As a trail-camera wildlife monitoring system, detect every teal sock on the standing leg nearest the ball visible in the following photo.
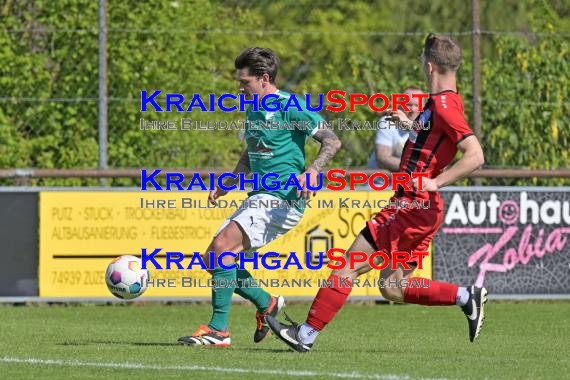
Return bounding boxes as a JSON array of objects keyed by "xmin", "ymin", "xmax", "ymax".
[{"xmin": 208, "ymin": 268, "xmax": 236, "ymax": 331}]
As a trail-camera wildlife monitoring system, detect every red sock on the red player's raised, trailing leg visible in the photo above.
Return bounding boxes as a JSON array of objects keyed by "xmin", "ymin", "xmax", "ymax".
[{"xmin": 404, "ymin": 277, "xmax": 459, "ymax": 306}]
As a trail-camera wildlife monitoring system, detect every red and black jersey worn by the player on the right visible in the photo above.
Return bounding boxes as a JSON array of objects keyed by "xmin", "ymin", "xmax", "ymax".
[{"xmin": 398, "ymin": 90, "xmax": 473, "ymax": 198}]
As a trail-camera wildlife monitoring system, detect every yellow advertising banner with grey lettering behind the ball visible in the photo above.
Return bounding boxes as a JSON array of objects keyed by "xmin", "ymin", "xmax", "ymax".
[{"xmin": 39, "ymin": 191, "xmax": 432, "ymax": 298}]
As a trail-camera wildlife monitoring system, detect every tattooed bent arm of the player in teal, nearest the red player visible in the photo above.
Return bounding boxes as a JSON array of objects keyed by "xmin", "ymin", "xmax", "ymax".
[{"xmin": 297, "ymin": 129, "xmax": 342, "ymax": 199}]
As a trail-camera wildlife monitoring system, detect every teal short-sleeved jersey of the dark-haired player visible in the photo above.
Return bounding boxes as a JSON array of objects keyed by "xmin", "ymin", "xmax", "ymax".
[{"xmin": 245, "ymin": 91, "xmax": 324, "ymax": 212}]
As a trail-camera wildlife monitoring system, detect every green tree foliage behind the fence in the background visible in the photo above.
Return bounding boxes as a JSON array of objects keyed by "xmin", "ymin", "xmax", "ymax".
[{"xmin": 0, "ymin": 0, "xmax": 570, "ymax": 185}]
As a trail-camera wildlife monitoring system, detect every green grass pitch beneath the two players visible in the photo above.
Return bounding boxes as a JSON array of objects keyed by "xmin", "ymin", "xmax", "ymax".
[{"xmin": 0, "ymin": 301, "xmax": 570, "ymax": 380}]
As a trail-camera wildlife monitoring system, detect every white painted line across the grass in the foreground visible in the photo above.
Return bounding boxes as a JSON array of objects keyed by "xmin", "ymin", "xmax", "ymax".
[{"xmin": 0, "ymin": 356, "xmax": 444, "ymax": 380}]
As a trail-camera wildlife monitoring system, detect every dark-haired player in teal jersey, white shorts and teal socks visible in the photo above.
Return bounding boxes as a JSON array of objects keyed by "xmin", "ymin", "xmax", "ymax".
[{"xmin": 178, "ymin": 48, "xmax": 341, "ymax": 347}]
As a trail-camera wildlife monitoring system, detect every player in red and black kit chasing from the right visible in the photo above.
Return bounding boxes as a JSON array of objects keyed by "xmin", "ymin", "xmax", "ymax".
[{"xmin": 267, "ymin": 34, "xmax": 487, "ymax": 352}]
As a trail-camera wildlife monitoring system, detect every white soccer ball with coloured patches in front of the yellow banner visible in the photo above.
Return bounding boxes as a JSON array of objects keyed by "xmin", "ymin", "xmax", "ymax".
[{"xmin": 105, "ymin": 255, "xmax": 150, "ymax": 300}]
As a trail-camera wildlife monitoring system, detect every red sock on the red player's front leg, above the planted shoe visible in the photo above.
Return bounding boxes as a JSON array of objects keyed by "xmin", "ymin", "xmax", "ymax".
[{"xmin": 307, "ymin": 275, "xmax": 352, "ymax": 330}]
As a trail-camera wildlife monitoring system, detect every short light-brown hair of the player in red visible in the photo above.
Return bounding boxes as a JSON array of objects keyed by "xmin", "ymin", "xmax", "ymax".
[{"xmin": 422, "ymin": 33, "xmax": 461, "ymax": 74}]
